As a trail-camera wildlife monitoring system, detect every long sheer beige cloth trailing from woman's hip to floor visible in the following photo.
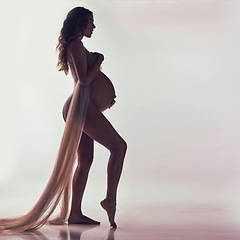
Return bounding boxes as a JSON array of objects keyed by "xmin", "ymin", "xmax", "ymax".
[{"xmin": 0, "ymin": 82, "xmax": 90, "ymax": 234}]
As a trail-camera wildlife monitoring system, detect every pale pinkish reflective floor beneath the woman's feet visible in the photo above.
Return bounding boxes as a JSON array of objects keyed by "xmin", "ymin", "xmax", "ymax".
[{"xmin": 0, "ymin": 204, "xmax": 240, "ymax": 240}]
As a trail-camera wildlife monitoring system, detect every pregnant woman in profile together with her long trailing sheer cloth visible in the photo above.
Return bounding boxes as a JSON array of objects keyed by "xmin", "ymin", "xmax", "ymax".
[{"xmin": 0, "ymin": 7, "xmax": 127, "ymax": 235}]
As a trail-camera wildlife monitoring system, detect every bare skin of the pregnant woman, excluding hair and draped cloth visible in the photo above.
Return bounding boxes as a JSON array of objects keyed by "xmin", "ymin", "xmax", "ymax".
[{"xmin": 63, "ymin": 15, "xmax": 127, "ymax": 228}]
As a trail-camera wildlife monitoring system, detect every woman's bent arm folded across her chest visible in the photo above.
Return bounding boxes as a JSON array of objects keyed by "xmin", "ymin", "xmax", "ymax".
[{"xmin": 68, "ymin": 39, "xmax": 104, "ymax": 86}]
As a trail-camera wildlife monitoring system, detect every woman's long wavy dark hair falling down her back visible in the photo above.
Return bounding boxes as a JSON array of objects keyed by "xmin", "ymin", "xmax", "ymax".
[{"xmin": 56, "ymin": 7, "xmax": 92, "ymax": 75}]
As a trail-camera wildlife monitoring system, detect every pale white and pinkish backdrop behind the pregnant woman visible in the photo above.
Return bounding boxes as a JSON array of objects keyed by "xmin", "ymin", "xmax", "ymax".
[{"xmin": 0, "ymin": 0, "xmax": 240, "ymax": 222}]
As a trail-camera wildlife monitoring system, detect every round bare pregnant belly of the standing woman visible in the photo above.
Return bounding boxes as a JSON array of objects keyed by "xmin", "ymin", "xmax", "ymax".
[{"xmin": 91, "ymin": 71, "xmax": 116, "ymax": 111}]
